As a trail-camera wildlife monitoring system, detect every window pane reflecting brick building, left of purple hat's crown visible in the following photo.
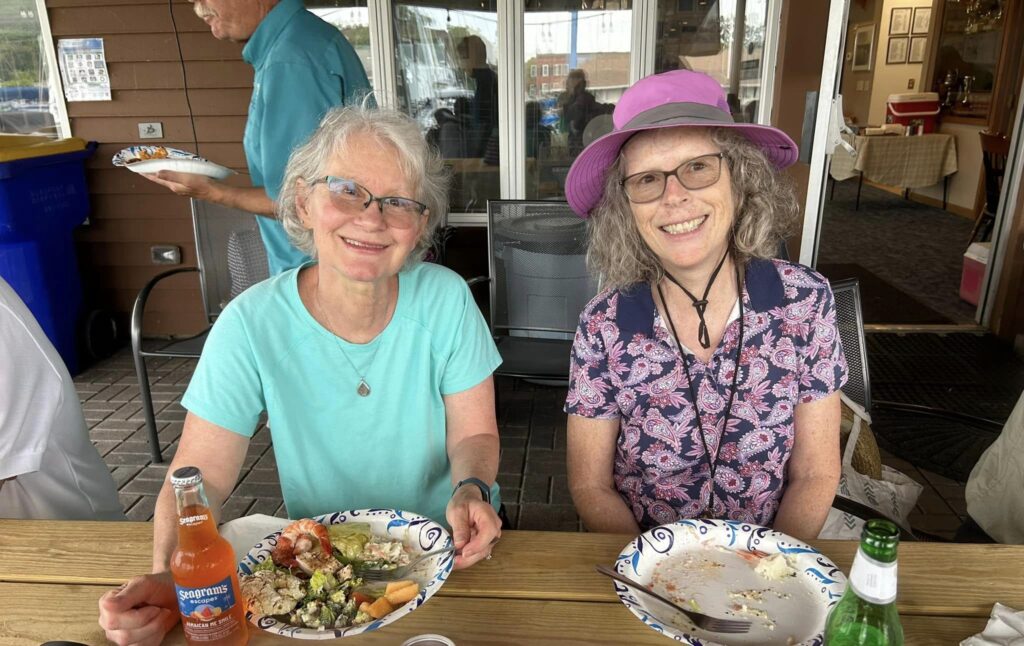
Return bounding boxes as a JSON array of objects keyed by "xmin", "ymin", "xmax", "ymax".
[{"xmin": 523, "ymin": 0, "xmax": 633, "ymax": 200}]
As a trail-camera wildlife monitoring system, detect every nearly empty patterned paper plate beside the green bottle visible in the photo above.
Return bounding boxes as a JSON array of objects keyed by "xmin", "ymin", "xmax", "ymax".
[{"xmin": 613, "ymin": 519, "xmax": 846, "ymax": 646}]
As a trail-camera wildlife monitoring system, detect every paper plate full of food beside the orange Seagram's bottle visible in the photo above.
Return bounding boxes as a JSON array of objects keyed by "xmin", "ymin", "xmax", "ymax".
[{"xmin": 239, "ymin": 509, "xmax": 455, "ymax": 639}]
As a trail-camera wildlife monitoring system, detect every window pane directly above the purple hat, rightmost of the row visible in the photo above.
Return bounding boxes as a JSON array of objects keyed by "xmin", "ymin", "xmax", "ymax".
[{"xmin": 654, "ymin": 0, "xmax": 767, "ymax": 122}]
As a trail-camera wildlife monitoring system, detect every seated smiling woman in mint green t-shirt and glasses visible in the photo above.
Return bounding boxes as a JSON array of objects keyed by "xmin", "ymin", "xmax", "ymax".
[{"xmin": 162, "ymin": 106, "xmax": 501, "ymax": 581}]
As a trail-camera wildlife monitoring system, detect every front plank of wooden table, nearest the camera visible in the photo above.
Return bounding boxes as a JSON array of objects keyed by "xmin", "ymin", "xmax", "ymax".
[{"xmin": 0, "ymin": 584, "xmax": 985, "ymax": 646}]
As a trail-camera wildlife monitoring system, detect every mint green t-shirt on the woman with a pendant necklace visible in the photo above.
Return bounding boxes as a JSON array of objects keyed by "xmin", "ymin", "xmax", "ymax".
[{"xmin": 182, "ymin": 263, "xmax": 501, "ymax": 524}]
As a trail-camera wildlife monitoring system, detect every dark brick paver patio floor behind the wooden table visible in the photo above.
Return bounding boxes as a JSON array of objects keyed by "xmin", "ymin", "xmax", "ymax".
[{"xmin": 75, "ymin": 349, "xmax": 967, "ymax": 537}]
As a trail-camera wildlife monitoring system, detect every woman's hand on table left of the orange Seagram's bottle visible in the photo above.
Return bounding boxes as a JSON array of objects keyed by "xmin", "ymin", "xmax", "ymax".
[{"xmin": 99, "ymin": 572, "xmax": 180, "ymax": 646}]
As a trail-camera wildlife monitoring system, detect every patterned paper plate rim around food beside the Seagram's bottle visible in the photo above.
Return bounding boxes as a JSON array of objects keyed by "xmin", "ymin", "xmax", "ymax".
[{"xmin": 239, "ymin": 509, "xmax": 455, "ymax": 639}]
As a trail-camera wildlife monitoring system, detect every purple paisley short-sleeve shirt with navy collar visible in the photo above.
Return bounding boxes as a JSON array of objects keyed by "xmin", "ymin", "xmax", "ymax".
[{"xmin": 565, "ymin": 260, "xmax": 847, "ymax": 527}]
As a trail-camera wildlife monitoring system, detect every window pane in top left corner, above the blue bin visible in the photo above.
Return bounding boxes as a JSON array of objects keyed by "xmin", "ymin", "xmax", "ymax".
[{"xmin": 0, "ymin": 0, "xmax": 61, "ymax": 137}]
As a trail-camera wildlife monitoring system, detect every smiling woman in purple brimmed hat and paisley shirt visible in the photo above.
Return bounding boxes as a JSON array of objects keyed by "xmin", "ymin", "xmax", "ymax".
[{"xmin": 565, "ymin": 71, "xmax": 847, "ymax": 540}]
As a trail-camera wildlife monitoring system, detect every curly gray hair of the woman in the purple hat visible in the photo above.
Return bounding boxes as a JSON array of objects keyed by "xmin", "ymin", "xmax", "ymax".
[{"xmin": 587, "ymin": 128, "xmax": 800, "ymax": 289}]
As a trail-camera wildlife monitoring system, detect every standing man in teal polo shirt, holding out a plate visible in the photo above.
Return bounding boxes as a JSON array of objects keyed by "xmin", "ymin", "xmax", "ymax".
[{"xmin": 146, "ymin": 0, "xmax": 371, "ymax": 275}]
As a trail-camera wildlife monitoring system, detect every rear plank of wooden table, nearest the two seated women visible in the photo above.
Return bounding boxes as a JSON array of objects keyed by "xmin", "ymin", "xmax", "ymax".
[{"xmin": 0, "ymin": 520, "xmax": 1024, "ymax": 616}]
